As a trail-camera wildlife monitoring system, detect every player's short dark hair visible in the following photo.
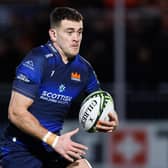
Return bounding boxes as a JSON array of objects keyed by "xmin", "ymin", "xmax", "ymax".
[{"xmin": 50, "ymin": 7, "xmax": 83, "ymax": 28}]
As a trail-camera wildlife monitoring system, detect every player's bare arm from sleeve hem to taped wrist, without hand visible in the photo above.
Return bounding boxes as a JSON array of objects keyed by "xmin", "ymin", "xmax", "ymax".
[{"xmin": 8, "ymin": 91, "xmax": 58, "ymax": 147}]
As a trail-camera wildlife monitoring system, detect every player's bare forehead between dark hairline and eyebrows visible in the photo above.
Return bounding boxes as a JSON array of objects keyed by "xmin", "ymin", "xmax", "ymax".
[{"xmin": 60, "ymin": 19, "xmax": 83, "ymax": 30}]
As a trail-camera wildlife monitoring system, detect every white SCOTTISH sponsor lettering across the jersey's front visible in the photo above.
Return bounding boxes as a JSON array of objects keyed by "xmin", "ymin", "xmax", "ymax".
[{"xmin": 40, "ymin": 90, "xmax": 72, "ymax": 104}]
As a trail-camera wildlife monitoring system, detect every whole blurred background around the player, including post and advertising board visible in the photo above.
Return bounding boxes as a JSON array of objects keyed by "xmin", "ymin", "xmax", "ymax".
[{"xmin": 0, "ymin": 0, "xmax": 168, "ymax": 168}]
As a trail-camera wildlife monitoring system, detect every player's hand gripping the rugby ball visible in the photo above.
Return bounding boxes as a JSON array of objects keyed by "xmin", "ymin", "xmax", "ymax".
[{"xmin": 96, "ymin": 112, "xmax": 119, "ymax": 132}]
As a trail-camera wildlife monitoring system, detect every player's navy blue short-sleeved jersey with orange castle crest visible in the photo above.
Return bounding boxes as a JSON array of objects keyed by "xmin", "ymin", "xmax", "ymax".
[{"xmin": 7, "ymin": 42, "xmax": 99, "ymax": 138}]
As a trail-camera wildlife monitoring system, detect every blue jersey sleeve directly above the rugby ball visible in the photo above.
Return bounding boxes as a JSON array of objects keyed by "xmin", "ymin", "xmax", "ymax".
[{"xmin": 86, "ymin": 65, "xmax": 100, "ymax": 93}]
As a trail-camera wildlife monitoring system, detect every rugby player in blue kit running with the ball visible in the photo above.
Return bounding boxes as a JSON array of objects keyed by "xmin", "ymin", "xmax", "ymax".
[{"xmin": 0, "ymin": 7, "xmax": 118, "ymax": 168}]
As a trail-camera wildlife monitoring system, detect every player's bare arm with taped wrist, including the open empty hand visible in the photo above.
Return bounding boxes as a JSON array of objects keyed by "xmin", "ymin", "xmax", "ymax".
[{"xmin": 8, "ymin": 91, "xmax": 87, "ymax": 161}]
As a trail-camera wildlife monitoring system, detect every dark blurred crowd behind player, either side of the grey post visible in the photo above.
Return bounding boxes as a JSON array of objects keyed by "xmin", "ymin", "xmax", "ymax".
[{"xmin": 0, "ymin": 0, "xmax": 168, "ymax": 88}]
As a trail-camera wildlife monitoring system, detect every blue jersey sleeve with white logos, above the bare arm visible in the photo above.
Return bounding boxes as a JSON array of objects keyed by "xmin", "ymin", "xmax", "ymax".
[{"xmin": 12, "ymin": 52, "xmax": 44, "ymax": 99}]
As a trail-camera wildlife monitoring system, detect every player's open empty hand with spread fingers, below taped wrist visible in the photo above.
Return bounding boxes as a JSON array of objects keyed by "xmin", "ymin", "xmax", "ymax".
[{"xmin": 54, "ymin": 128, "xmax": 88, "ymax": 162}]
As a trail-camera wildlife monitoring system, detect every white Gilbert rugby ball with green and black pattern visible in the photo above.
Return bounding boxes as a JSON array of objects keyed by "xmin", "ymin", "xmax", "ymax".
[{"xmin": 79, "ymin": 90, "xmax": 114, "ymax": 132}]
